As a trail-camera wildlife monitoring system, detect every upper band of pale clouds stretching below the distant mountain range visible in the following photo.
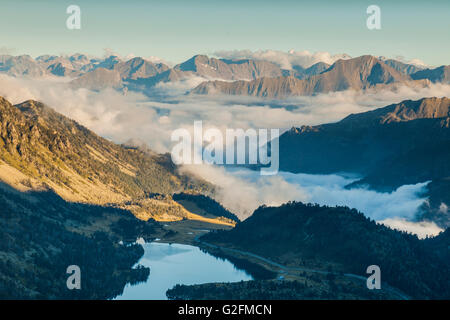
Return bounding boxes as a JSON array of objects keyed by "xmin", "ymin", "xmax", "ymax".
[{"xmin": 0, "ymin": 75, "xmax": 450, "ymax": 152}]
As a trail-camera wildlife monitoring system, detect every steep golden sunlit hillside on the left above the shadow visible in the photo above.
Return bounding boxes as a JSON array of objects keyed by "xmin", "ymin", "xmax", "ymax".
[{"xmin": 0, "ymin": 98, "xmax": 211, "ymax": 219}]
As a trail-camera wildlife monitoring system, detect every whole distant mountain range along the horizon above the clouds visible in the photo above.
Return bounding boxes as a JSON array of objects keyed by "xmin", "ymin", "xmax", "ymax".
[{"xmin": 0, "ymin": 54, "xmax": 450, "ymax": 98}]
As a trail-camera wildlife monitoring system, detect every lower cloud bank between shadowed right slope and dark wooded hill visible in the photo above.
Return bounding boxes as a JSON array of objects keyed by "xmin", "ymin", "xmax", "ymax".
[{"xmin": 184, "ymin": 165, "xmax": 443, "ymax": 238}]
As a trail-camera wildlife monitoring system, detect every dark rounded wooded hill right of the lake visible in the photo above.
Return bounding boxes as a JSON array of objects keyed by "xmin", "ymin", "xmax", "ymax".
[{"xmin": 202, "ymin": 202, "xmax": 450, "ymax": 299}]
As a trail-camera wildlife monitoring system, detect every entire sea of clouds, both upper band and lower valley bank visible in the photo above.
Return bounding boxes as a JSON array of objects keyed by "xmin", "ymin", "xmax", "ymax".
[{"xmin": 0, "ymin": 75, "xmax": 450, "ymax": 236}]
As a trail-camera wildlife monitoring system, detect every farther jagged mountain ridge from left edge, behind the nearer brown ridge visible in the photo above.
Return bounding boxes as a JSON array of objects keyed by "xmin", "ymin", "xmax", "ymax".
[{"xmin": 0, "ymin": 54, "xmax": 329, "ymax": 80}]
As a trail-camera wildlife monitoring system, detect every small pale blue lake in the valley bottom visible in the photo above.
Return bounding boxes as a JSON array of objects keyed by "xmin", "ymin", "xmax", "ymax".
[{"xmin": 116, "ymin": 242, "xmax": 252, "ymax": 300}]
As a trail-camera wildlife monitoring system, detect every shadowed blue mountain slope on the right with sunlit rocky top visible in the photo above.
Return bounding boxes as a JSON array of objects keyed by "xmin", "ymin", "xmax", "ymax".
[{"xmin": 280, "ymin": 97, "xmax": 450, "ymax": 227}]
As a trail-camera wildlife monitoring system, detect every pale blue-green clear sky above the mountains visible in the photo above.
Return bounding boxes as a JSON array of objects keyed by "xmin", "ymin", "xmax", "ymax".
[{"xmin": 0, "ymin": 0, "xmax": 450, "ymax": 65}]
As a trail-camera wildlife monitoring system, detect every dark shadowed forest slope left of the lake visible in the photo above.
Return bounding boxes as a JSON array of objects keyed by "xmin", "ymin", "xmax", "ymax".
[{"xmin": 0, "ymin": 184, "xmax": 160, "ymax": 299}]
